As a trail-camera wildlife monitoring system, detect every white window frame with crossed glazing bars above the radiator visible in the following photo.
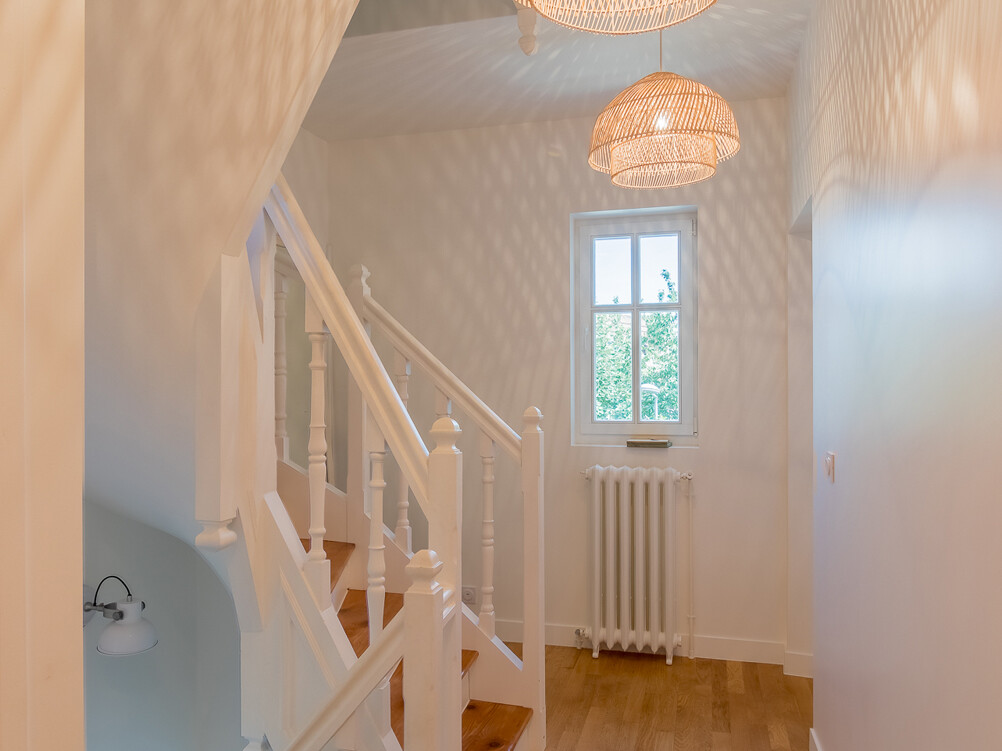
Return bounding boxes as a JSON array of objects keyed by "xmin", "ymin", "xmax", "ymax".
[{"xmin": 570, "ymin": 206, "xmax": 698, "ymax": 446}]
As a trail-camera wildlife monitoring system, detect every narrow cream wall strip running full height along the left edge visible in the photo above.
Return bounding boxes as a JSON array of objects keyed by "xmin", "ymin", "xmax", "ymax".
[{"xmin": 0, "ymin": 0, "xmax": 84, "ymax": 751}]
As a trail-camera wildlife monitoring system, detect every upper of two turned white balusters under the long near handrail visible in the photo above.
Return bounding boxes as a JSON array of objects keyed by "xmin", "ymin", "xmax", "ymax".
[{"xmin": 306, "ymin": 293, "xmax": 331, "ymax": 608}]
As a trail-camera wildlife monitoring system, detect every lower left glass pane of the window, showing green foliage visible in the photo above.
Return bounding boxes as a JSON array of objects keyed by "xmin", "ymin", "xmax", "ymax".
[{"xmin": 594, "ymin": 313, "xmax": 633, "ymax": 423}]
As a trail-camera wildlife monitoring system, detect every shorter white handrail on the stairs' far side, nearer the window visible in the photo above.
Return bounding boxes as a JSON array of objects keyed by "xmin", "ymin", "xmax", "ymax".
[{"xmin": 365, "ymin": 295, "xmax": 522, "ymax": 461}]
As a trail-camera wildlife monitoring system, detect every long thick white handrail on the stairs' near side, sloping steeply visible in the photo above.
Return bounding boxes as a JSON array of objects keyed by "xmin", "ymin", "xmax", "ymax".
[{"xmin": 265, "ymin": 174, "xmax": 430, "ymax": 509}]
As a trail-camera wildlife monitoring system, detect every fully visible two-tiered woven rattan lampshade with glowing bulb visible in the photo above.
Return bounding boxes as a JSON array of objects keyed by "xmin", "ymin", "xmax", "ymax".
[{"xmin": 588, "ymin": 71, "xmax": 740, "ymax": 188}]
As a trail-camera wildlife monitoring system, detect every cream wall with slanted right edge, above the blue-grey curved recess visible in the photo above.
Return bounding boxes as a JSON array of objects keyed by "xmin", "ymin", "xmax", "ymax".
[{"xmin": 86, "ymin": 0, "xmax": 356, "ymax": 541}]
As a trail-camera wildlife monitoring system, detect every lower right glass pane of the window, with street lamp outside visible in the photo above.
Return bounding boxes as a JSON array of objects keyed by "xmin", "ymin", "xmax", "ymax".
[{"xmin": 640, "ymin": 310, "xmax": 678, "ymax": 423}]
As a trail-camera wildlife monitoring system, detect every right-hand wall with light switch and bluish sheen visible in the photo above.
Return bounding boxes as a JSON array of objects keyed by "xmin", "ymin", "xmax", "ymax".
[{"xmin": 792, "ymin": 0, "xmax": 1002, "ymax": 751}]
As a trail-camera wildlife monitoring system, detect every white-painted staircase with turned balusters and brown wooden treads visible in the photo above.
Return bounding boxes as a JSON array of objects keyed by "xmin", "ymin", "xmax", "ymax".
[{"xmin": 196, "ymin": 175, "xmax": 546, "ymax": 751}]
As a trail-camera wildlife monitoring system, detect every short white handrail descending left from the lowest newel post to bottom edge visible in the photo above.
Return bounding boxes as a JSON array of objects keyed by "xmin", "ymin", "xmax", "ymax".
[{"xmin": 287, "ymin": 614, "xmax": 404, "ymax": 751}]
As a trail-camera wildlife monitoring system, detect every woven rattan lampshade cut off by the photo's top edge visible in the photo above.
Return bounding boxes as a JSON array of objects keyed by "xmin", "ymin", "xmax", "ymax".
[{"xmin": 515, "ymin": 0, "xmax": 716, "ymax": 34}]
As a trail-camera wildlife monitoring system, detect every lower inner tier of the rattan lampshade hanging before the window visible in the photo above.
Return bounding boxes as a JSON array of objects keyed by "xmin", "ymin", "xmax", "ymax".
[{"xmin": 609, "ymin": 133, "xmax": 716, "ymax": 188}]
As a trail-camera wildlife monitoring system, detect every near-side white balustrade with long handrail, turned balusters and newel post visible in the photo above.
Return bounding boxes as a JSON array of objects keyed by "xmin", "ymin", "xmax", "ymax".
[{"xmin": 265, "ymin": 176, "xmax": 462, "ymax": 751}]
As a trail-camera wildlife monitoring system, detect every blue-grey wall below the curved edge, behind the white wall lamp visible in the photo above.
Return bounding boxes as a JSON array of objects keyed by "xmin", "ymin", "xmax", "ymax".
[{"xmin": 84, "ymin": 503, "xmax": 244, "ymax": 751}]
